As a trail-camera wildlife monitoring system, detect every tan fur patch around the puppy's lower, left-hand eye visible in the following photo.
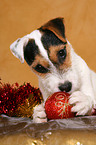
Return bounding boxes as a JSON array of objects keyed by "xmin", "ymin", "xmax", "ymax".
[{"xmin": 30, "ymin": 55, "xmax": 49, "ymax": 77}]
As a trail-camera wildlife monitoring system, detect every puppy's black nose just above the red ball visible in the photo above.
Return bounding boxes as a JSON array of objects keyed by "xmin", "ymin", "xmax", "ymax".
[{"xmin": 58, "ymin": 81, "xmax": 72, "ymax": 92}]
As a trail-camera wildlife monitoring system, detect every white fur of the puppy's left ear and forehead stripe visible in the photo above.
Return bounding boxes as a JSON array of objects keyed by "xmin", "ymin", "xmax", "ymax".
[{"xmin": 10, "ymin": 30, "xmax": 48, "ymax": 63}]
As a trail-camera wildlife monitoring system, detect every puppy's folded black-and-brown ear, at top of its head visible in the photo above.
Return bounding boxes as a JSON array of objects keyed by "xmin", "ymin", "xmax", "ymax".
[{"xmin": 40, "ymin": 18, "xmax": 66, "ymax": 43}]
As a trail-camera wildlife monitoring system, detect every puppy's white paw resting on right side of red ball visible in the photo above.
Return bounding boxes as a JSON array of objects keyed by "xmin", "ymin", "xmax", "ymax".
[{"xmin": 69, "ymin": 91, "xmax": 93, "ymax": 115}]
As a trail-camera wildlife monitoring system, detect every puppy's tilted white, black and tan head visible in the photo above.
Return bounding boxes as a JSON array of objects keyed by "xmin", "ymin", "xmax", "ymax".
[{"xmin": 10, "ymin": 18, "xmax": 80, "ymax": 98}]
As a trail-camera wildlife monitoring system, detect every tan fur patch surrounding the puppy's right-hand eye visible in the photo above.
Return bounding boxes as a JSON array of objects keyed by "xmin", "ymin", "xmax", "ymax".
[{"xmin": 49, "ymin": 44, "xmax": 72, "ymax": 70}]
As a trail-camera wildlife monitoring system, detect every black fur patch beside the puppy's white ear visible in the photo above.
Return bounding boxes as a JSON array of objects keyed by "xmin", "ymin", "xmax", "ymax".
[{"xmin": 24, "ymin": 39, "xmax": 39, "ymax": 65}]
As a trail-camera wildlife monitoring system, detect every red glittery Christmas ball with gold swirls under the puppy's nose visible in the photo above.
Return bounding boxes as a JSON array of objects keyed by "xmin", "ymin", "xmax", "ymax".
[{"xmin": 45, "ymin": 92, "xmax": 75, "ymax": 119}]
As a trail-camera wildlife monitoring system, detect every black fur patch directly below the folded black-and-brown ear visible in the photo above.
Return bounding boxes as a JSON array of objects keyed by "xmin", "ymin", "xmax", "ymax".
[{"xmin": 41, "ymin": 30, "xmax": 65, "ymax": 50}]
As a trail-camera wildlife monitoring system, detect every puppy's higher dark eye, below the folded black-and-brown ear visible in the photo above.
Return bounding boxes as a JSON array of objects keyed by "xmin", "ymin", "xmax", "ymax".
[{"xmin": 57, "ymin": 46, "xmax": 67, "ymax": 63}]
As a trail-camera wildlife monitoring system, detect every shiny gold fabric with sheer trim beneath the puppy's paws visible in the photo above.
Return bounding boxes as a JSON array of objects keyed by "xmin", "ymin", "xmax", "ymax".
[{"xmin": 0, "ymin": 116, "xmax": 96, "ymax": 145}]
